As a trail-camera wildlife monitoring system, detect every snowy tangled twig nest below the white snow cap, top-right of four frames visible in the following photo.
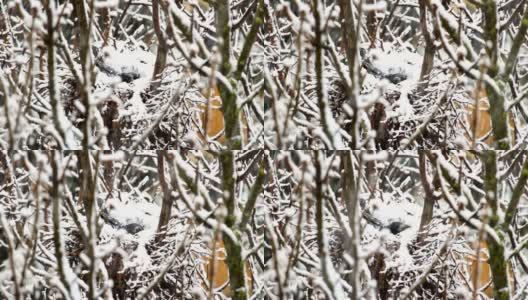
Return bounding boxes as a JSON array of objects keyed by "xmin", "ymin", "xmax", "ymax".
[{"xmin": 363, "ymin": 68, "xmax": 461, "ymax": 150}]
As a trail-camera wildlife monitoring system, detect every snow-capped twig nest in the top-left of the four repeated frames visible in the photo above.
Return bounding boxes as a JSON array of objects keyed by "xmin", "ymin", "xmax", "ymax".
[{"xmin": 36, "ymin": 39, "xmax": 213, "ymax": 149}]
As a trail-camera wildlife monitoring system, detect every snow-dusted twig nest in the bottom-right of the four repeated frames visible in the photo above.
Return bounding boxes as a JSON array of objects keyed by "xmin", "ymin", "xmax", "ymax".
[{"xmin": 369, "ymin": 218, "xmax": 466, "ymax": 299}]
